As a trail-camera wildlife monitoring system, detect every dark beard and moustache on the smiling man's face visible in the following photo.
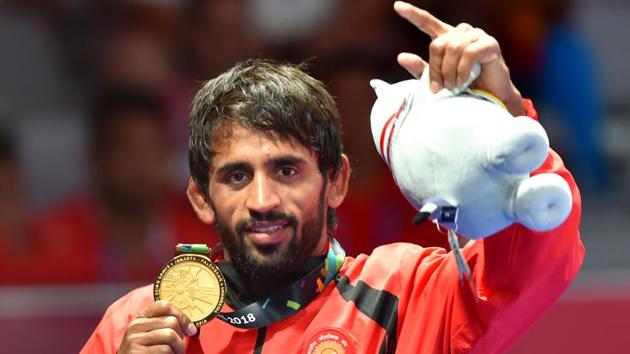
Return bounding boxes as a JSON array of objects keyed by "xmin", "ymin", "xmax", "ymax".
[{"xmin": 210, "ymin": 185, "xmax": 326, "ymax": 279}]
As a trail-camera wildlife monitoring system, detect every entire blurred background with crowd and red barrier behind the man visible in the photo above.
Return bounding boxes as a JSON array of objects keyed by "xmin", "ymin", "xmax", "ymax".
[{"xmin": 0, "ymin": 0, "xmax": 630, "ymax": 354}]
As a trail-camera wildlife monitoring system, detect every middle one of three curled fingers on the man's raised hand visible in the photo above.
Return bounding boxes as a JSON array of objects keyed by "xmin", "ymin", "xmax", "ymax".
[{"xmin": 441, "ymin": 23, "xmax": 473, "ymax": 90}]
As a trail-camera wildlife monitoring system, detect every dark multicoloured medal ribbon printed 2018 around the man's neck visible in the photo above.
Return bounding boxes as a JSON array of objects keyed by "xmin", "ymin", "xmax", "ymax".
[{"xmin": 177, "ymin": 237, "xmax": 346, "ymax": 328}]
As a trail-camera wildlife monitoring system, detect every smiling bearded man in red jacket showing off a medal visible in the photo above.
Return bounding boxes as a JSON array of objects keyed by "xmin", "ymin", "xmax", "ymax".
[{"xmin": 84, "ymin": 2, "xmax": 583, "ymax": 353}]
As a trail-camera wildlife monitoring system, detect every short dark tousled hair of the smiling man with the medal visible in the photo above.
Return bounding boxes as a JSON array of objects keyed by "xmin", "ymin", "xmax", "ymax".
[{"xmin": 188, "ymin": 59, "xmax": 343, "ymax": 229}]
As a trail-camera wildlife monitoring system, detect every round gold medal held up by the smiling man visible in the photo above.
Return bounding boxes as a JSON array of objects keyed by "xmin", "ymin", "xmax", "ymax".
[{"xmin": 153, "ymin": 253, "xmax": 226, "ymax": 327}]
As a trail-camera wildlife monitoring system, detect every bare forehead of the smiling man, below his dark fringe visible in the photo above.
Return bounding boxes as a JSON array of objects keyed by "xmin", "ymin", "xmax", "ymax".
[{"xmin": 211, "ymin": 123, "xmax": 317, "ymax": 170}]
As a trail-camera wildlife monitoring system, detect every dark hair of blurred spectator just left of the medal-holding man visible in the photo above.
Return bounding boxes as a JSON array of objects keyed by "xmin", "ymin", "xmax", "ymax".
[{"xmin": 89, "ymin": 87, "xmax": 168, "ymax": 153}]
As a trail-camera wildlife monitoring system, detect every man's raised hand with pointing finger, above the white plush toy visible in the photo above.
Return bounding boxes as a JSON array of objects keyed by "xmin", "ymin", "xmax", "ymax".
[{"xmin": 394, "ymin": 1, "xmax": 524, "ymax": 116}]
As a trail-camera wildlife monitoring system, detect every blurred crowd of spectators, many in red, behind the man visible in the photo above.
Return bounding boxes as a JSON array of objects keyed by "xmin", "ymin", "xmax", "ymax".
[{"xmin": 0, "ymin": 0, "xmax": 609, "ymax": 284}]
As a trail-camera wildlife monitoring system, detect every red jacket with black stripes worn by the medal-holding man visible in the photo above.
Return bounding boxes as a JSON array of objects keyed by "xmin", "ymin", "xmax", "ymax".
[{"xmin": 82, "ymin": 100, "xmax": 584, "ymax": 354}]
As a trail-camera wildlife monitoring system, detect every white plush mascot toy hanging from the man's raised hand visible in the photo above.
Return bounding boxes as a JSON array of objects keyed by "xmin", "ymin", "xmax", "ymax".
[{"xmin": 370, "ymin": 65, "xmax": 571, "ymax": 245}]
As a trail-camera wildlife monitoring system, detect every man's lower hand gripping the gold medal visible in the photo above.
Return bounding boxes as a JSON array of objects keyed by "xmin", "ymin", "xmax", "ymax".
[{"xmin": 118, "ymin": 301, "xmax": 197, "ymax": 354}]
